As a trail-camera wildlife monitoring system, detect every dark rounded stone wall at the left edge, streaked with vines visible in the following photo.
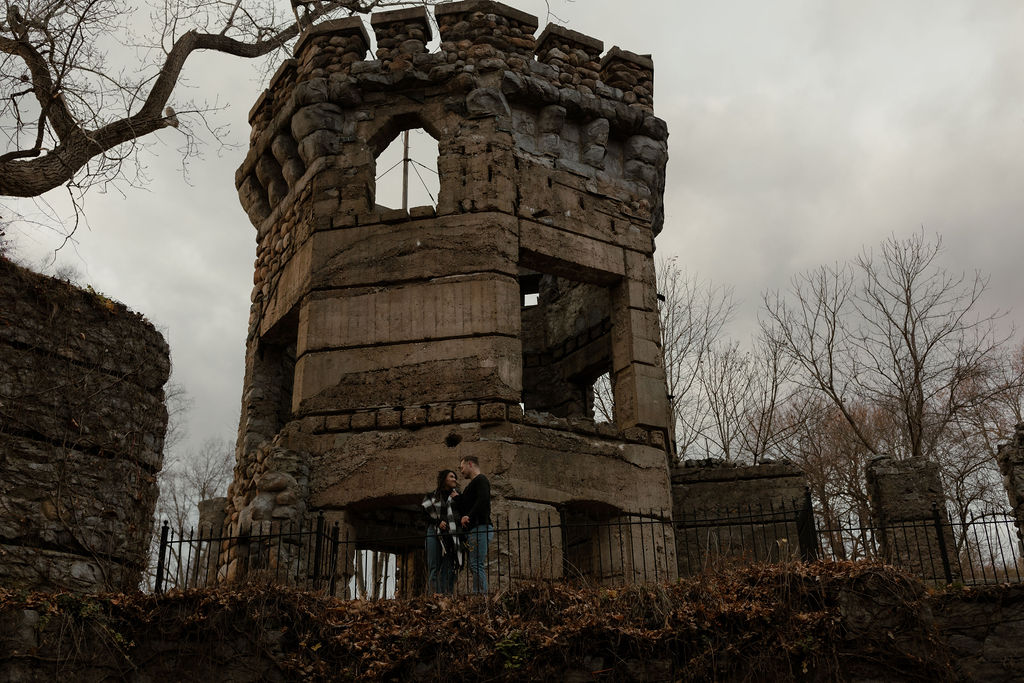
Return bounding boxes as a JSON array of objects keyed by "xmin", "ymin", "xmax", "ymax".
[{"xmin": 0, "ymin": 258, "xmax": 170, "ymax": 591}]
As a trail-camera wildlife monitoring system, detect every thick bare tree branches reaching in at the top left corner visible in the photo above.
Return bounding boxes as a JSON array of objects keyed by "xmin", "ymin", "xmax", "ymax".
[{"xmin": 0, "ymin": 0, "xmax": 437, "ymax": 197}]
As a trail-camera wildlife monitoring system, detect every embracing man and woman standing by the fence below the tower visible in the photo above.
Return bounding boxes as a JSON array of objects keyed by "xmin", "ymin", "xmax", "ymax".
[{"xmin": 423, "ymin": 456, "xmax": 494, "ymax": 593}]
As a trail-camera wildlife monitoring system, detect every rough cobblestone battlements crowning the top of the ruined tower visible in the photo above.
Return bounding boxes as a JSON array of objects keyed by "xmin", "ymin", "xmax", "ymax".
[{"xmin": 236, "ymin": 0, "xmax": 668, "ymax": 323}]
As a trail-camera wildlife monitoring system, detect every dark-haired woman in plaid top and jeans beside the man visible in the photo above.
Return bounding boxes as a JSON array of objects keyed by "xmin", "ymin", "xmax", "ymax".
[{"xmin": 423, "ymin": 470, "xmax": 462, "ymax": 593}]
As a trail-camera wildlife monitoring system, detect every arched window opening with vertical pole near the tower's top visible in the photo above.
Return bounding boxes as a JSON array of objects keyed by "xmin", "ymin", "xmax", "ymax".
[{"xmin": 376, "ymin": 128, "xmax": 440, "ymax": 210}]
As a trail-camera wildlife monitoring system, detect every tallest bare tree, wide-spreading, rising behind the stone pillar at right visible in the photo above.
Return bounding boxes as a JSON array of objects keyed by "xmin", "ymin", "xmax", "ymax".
[{"xmin": 764, "ymin": 233, "xmax": 1020, "ymax": 459}]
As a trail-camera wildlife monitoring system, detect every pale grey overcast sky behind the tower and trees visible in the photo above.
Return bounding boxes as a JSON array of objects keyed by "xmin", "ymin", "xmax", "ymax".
[{"xmin": 11, "ymin": 0, "xmax": 1024, "ymax": 458}]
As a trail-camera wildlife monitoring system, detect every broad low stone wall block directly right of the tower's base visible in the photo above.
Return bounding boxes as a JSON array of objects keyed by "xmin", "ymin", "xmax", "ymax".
[{"xmin": 672, "ymin": 460, "xmax": 807, "ymax": 575}]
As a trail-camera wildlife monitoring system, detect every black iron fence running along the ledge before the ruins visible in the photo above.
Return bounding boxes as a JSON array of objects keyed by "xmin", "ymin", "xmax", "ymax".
[{"xmin": 155, "ymin": 496, "xmax": 1024, "ymax": 598}]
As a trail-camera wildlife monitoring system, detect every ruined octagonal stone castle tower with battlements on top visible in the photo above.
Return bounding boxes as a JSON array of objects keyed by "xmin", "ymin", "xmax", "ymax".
[{"xmin": 222, "ymin": 0, "xmax": 675, "ymax": 589}]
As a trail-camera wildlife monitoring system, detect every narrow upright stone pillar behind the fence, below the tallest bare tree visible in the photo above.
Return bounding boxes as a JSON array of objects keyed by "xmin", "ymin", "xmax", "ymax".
[{"xmin": 866, "ymin": 456, "xmax": 959, "ymax": 583}]
